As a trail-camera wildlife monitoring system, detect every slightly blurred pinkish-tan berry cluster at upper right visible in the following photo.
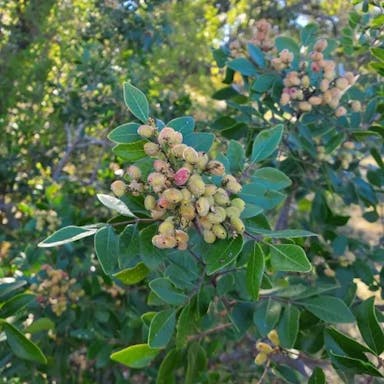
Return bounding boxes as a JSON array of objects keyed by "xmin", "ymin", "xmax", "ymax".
[{"xmin": 271, "ymin": 39, "xmax": 361, "ymax": 117}]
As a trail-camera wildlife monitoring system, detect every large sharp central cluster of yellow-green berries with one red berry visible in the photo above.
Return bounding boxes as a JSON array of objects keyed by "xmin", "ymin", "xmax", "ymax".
[{"xmin": 111, "ymin": 125, "xmax": 245, "ymax": 250}]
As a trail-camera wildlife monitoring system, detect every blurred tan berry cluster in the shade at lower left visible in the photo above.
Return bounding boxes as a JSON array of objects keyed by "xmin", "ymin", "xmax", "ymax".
[{"xmin": 31, "ymin": 265, "xmax": 84, "ymax": 316}]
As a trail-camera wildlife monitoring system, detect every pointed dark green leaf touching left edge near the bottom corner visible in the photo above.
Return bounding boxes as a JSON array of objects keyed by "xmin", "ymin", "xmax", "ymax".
[{"xmin": 0, "ymin": 320, "xmax": 47, "ymax": 364}]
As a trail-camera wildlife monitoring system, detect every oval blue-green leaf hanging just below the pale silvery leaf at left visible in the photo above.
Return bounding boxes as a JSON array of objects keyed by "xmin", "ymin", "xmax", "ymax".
[{"xmin": 94, "ymin": 226, "xmax": 119, "ymax": 275}]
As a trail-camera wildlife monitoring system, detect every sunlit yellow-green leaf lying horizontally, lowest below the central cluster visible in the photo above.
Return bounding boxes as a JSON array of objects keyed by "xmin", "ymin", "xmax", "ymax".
[{"xmin": 111, "ymin": 344, "xmax": 160, "ymax": 368}]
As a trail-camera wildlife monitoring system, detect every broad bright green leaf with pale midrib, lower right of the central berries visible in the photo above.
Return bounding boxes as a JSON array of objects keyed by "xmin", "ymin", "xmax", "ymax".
[{"xmin": 269, "ymin": 244, "xmax": 312, "ymax": 272}]
